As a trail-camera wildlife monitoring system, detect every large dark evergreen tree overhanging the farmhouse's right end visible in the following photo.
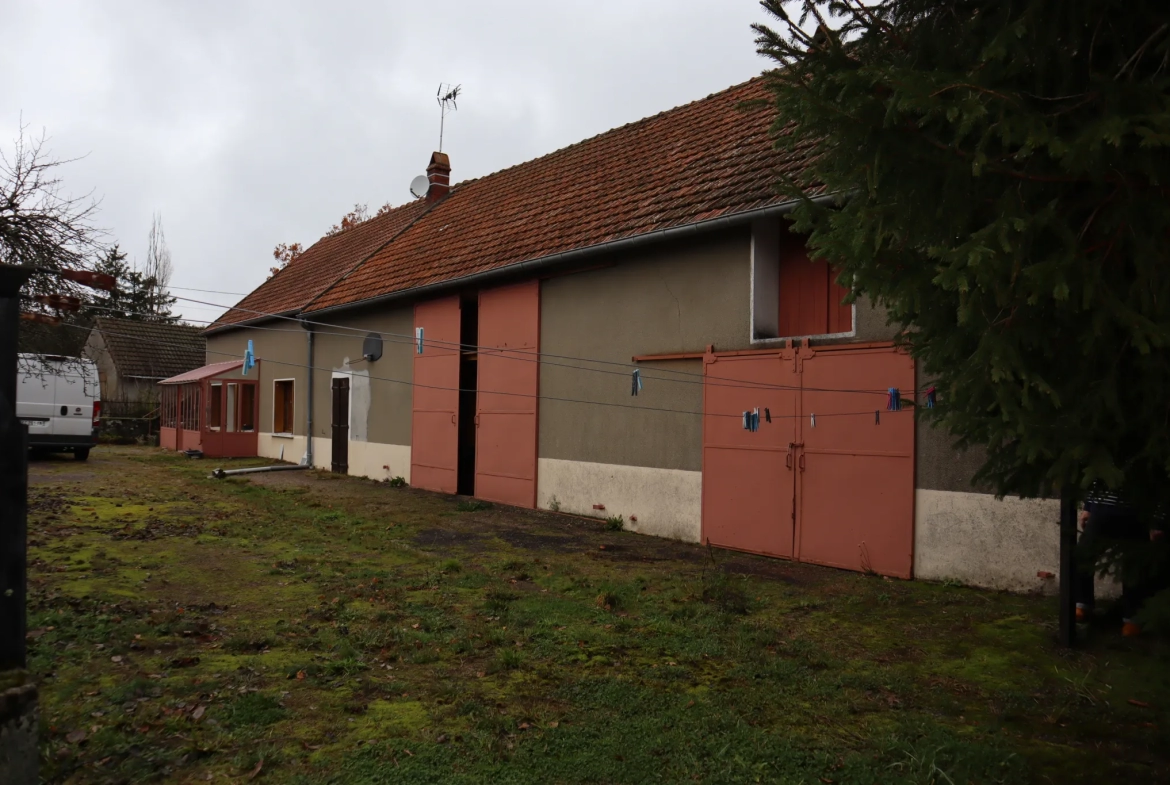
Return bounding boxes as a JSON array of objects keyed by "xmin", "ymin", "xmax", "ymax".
[{"xmin": 755, "ymin": 0, "xmax": 1170, "ymax": 511}]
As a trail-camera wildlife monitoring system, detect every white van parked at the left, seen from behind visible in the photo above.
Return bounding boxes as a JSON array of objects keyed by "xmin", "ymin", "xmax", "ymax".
[{"xmin": 16, "ymin": 354, "xmax": 102, "ymax": 461}]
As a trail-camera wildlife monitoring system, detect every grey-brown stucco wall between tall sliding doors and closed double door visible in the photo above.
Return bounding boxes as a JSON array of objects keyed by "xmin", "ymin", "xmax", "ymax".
[{"xmin": 538, "ymin": 227, "xmax": 751, "ymax": 470}]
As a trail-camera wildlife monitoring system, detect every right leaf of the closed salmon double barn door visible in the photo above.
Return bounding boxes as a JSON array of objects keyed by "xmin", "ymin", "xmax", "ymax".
[{"xmin": 796, "ymin": 346, "xmax": 914, "ymax": 578}]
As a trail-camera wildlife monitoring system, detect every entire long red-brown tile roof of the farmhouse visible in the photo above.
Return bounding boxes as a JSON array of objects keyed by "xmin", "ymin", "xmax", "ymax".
[{"xmin": 209, "ymin": 77, "xmax": 810, "ymax": 330}]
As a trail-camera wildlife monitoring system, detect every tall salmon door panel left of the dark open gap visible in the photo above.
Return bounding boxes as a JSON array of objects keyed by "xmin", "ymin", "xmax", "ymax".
[{"xmin": 411, "ymin": 297, "xmax": 460, "ymax": 494}]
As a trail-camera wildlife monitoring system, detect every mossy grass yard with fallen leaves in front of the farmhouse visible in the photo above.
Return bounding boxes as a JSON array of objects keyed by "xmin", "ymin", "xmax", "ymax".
[{"xmin": 29, "ymin": 447, "xmax": 1170, "ymax": 785}]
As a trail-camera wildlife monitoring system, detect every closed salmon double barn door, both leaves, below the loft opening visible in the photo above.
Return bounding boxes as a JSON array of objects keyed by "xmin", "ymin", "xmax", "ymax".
[{"xmin": 702, "ymin": 345, "xmax": 914, "ymax": 578}]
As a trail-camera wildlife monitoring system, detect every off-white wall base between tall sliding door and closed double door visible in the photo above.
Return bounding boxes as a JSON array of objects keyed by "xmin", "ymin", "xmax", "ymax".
[{"xmin": 536, "ymin": 457, "xmax": 703, "ymax": 543}]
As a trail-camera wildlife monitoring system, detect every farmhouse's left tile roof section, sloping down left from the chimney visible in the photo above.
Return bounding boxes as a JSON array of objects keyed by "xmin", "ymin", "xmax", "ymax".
[{"xmin": 207, "ymin": 200, "xmax": 427, "ymax": 330}]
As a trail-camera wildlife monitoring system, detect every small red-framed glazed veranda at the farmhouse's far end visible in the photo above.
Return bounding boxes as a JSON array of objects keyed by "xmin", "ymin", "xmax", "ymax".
[{"xmin": 159, "ymin": 360, "xmax": 260, "ymax": 457}]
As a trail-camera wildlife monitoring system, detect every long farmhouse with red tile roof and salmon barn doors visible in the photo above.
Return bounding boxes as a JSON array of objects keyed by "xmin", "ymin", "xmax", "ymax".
[{"xmin": 196, "ymin": 80, "xmax": 1058, "ymax": 590}]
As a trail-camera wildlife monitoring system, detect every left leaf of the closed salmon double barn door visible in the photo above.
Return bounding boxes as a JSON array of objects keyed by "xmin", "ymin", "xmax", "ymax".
[{"xmin": 702, "ymin": 349, "xmax": 799, "ymax": 557}]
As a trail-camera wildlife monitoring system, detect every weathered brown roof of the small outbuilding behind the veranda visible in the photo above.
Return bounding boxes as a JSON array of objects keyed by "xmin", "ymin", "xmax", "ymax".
[{"xmin": 94, "ymin": 317, "xmax": 207, "ymax": 379}]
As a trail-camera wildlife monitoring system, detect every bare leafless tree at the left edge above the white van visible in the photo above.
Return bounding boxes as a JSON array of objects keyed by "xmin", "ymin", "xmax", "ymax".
[{"xmin": 0, "ymin": 123, "xmax": 103, "ymax": 354}]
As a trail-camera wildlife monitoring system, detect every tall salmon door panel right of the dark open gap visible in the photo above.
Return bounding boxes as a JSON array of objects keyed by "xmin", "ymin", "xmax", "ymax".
[{"xmin": 475, "ymin": 281, "xmax": 541, "ymax": 508}]
